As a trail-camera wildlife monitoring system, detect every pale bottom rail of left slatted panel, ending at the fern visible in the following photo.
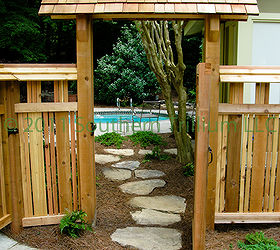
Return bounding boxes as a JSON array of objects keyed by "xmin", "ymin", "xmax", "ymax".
[{"xmin": 22, "ymin": 214, "xmax": 65, "ymax": 227}]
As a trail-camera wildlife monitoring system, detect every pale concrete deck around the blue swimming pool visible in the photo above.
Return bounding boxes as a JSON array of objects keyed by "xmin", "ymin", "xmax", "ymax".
[{"xmin": 94, "ymin": 108, "xmax": 171, "ymax": 135}]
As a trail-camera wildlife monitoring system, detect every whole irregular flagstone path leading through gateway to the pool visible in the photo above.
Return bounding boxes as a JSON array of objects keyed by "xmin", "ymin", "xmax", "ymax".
[{"xmin": 98, "ymin": 148, "xmax": 186, "ymax": 250}]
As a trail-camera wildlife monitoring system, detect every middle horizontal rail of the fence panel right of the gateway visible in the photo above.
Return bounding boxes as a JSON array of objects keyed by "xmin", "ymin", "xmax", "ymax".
[{"xmin": 218, "ymin": 103, "xmax": 280, "ymax": 115}]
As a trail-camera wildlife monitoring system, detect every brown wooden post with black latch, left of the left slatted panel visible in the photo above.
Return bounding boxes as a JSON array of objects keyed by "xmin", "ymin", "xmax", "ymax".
[{"xmin": 5, "ymin": 82, "xmax": 23, "ymax": 233}]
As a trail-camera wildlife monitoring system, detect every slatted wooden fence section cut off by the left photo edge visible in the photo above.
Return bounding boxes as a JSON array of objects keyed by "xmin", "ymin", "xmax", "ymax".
[{"xmin": 0, "ymin": 105, "xmax": 12, "ymax": 229}]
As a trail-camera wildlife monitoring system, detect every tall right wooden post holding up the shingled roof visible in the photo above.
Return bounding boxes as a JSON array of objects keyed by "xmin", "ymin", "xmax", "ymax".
[{"xmin": 205, "ymin": 15, "xmax": 220, "ymax": 229}]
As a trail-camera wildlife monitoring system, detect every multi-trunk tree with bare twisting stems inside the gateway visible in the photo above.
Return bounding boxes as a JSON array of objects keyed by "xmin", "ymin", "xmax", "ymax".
[{"xmin": 136, "ymin": 21, "xmax": 193, "ymax": 164}]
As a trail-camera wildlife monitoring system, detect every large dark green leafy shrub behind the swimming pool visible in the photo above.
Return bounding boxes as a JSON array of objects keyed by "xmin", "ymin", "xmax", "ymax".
[{"xmin": 94, "ymin": 25, "xmax": 159, "ymax": 104}]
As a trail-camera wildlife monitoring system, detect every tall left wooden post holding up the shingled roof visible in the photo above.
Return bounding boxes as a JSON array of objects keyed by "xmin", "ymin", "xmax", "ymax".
[{"xmin": 76, "ymin": 15, "xmax": 96, "ymax": 222}]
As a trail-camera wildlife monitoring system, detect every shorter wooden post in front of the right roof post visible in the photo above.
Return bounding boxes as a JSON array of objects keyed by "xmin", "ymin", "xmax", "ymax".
[{"xmin": 192, "ymin": 63, "xmax": 211, "ymax": 250}]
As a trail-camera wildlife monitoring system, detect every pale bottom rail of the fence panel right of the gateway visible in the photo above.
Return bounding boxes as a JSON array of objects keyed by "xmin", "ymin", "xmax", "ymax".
[{"xmin": 215, "ymin": 213, "xmax": 280, "ymax": 224}]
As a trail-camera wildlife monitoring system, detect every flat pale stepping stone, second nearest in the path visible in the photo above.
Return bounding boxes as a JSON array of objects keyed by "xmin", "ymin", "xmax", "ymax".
[{"xmin": 130, "ymin": 209, "xmax": 181, "ymax": 226}]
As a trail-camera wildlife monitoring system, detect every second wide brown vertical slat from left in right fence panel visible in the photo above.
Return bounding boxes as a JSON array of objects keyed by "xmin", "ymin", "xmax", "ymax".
[{"xmin": 250, "ymin": 83, "xmax": 267, "ymax": 212}]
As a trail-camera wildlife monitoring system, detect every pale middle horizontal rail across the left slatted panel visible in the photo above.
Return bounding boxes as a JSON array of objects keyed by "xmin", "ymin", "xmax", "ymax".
[{"xmin": 15, "ymin": 102, "xmax": 78, "ymax": 113}]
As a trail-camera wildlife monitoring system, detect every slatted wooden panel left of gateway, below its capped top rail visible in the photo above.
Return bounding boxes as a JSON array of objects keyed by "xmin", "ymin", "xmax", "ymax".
[{"xmin": 15, "ymin": 81, "xmax": 79, "ymax": 226}]
